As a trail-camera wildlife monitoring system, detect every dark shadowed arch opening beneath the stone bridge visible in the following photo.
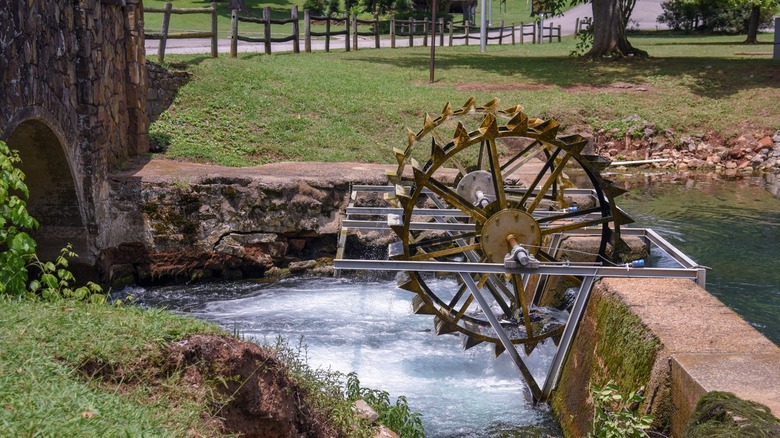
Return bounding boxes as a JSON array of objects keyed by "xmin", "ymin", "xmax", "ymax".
[{"xmin": 5, "ymin": 111, "xmax": 94, "ymax": 264}]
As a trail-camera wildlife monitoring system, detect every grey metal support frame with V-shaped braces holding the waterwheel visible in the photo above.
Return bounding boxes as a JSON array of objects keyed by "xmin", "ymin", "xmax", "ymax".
[{"xmin": 333, "ymin": 185, "xmax": 706, "ymax": 402}]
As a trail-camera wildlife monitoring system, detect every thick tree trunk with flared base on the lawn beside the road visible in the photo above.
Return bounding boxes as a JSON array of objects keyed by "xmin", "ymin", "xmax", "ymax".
[{"xmin": 585, "ymin": 0, "xmax": 647, "ymax": 59}]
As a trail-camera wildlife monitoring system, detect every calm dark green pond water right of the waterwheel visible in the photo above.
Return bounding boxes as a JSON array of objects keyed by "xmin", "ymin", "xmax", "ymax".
[{"xmin": 608, "ymin": 174, "xmax": 780, "ymax": 344}]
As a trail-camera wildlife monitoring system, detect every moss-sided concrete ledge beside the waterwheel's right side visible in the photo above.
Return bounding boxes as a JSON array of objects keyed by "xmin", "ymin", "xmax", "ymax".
[{"xmin": 553, "ymin": 278, "xmax": 780, "ymax": 436}]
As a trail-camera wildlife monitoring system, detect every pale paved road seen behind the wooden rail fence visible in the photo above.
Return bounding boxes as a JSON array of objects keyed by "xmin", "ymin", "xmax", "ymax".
[{"xmin": 146, "ymin": 0, "xmax": 665, "ymax": 56}]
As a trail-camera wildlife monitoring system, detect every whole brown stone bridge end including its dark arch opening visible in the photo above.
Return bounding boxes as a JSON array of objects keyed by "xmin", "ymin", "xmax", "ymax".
[{"xmin": 0, "ymin": 0, "xmax": 149, "ymax": 264}]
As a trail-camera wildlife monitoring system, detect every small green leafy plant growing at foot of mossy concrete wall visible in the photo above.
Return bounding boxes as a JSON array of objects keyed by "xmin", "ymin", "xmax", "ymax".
[{"xmin": 588, "ymin": 380, "xmax": 654, "ymax": 438}]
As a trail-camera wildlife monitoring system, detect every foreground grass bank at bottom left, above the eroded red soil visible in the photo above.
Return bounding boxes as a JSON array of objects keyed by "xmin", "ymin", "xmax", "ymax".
[{"xmin": 0, "ymin": 298, "xmax": 222, "ymax": 436}]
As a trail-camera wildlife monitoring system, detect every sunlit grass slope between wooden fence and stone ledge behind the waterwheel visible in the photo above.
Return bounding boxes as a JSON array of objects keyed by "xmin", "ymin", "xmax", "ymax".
[{"xmin": 150, "ymin": 34, "xmax": 780, "ymax": 166}]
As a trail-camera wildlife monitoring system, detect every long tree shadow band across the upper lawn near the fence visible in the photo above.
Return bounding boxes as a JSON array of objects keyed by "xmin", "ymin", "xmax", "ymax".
[{"xmin": 340, "ymin": 53, "xmax": 780, "ymax": 98}]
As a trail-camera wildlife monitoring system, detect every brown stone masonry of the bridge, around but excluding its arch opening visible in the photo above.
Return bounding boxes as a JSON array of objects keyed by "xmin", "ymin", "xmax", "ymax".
[{"xmin": 0, "ymin": 0, "xmax": 149, "ymax": 258}]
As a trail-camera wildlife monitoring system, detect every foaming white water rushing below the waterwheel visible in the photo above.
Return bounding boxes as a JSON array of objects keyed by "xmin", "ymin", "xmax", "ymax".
[{"xmin": 127, "ymin": 278, "xmax": 560, "ymax": 437}]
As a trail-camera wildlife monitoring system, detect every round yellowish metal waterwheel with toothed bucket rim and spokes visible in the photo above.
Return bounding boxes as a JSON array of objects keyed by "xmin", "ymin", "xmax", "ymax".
[{"xmin": 386, "ymin": 98, "xmax": 631, "ymax": 398}]
